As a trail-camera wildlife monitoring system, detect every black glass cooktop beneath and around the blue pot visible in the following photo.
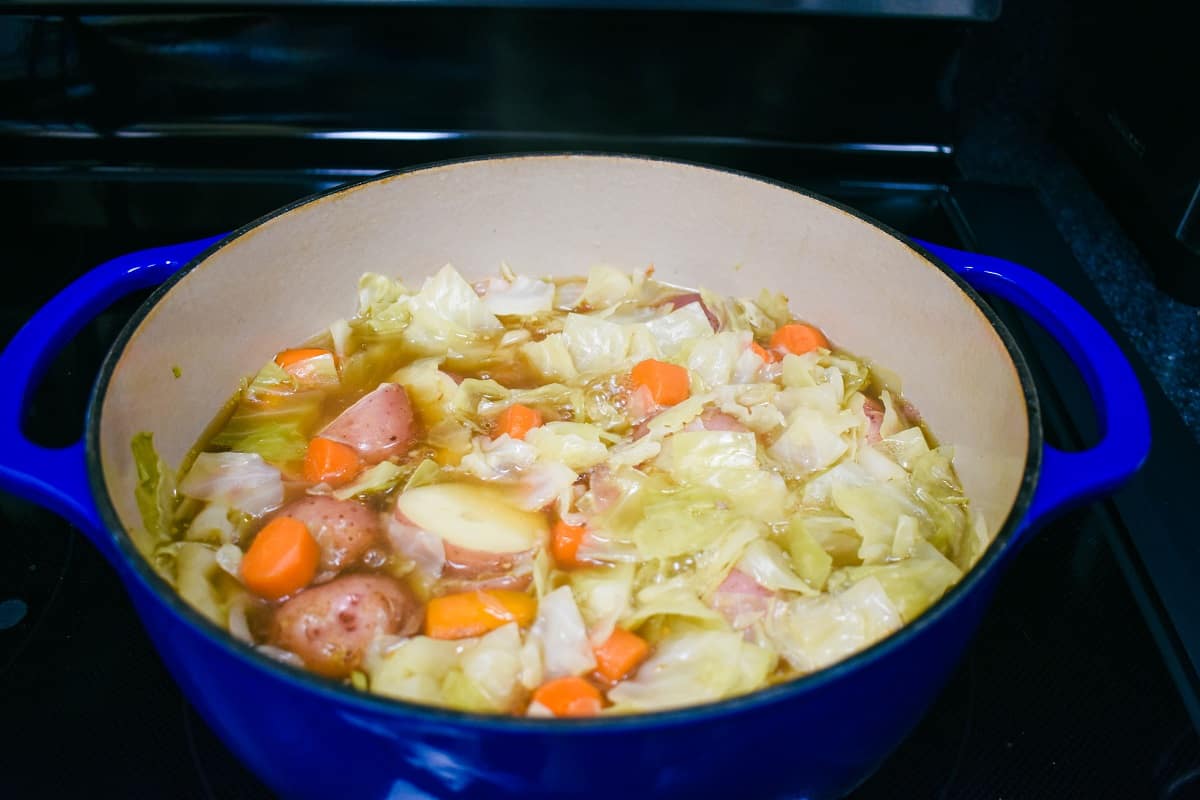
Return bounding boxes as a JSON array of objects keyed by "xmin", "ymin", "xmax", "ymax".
[{"xmin": 0, "ymin": 149, "xmax": 1200, "ymax": 800}]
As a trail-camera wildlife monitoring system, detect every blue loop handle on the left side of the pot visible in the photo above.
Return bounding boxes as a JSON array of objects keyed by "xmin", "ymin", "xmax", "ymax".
[{"xmin": 0, "ymin": 236, "xmax": 221, "ymax": 558}]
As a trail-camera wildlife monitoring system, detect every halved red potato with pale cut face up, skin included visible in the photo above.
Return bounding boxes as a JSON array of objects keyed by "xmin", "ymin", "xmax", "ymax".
[{"xmin": 396, "ymin": 483, "xmax": 550, "ymax": 579}]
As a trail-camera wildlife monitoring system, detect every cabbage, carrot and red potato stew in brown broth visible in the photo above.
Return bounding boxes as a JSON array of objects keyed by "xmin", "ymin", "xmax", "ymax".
[{"xmin": 132, "ymin": 265, "xmax": 989, "ymax": 717}]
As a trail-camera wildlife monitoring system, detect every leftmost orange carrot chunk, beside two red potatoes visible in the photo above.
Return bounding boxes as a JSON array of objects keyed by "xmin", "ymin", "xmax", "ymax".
[{"xmin": 241, "ymin": 517, "xmax": 320, "ymax": 600}]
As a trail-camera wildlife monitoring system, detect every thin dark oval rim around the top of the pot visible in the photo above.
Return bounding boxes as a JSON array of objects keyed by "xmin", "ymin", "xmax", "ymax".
[{"xmin": 84, "ymin": 151, "xmax": 1043, "ymax": 735}]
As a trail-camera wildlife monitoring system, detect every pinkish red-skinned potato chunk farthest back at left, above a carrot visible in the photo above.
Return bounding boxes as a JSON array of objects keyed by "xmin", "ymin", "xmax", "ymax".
[{"xmin": 319, "ymin": 384, "xmax": 416, "ymax": 465}]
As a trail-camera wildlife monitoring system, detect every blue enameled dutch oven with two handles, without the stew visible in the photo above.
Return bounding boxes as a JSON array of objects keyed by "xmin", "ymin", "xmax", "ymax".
[{"xmin": 0, "ymin": 155, "xmax": 1150, "ymax": 800}]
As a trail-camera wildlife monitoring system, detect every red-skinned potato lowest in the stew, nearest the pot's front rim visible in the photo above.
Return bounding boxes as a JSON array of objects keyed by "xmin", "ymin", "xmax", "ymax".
[{"xmin": 270, "ymin": 575, "xmax": 422, "ymax": 678}]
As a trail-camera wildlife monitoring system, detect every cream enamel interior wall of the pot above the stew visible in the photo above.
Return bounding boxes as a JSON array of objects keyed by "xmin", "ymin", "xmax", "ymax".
[{"xmin": 100, "ymin": 156, "xmax": 1028, "ymax": 546}]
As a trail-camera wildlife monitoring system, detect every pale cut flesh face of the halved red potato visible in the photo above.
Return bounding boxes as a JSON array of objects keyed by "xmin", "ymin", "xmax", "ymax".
[{"xmin": 396, "ymin": 483, "xmax": 548, "ymax": 553}]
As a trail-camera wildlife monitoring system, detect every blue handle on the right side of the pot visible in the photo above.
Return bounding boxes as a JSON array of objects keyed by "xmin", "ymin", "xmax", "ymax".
[{"xmin": 917, "ymin": 241, "xmax": 1150, "ymax": 530}]
